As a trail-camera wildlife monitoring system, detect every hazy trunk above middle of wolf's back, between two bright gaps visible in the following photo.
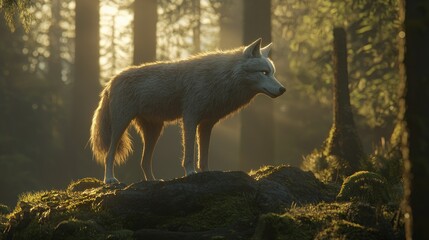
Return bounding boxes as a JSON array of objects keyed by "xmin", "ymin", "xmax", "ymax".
[{"xmin": 133, "ymin": 0, "xmax": 158, "ymax": 65}]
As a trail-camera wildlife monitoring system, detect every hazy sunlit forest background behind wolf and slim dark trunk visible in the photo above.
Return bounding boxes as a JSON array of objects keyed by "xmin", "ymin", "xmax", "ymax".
[{"xmin": 0, "ymin": 0, "xmax": 399, "ymax": 205}]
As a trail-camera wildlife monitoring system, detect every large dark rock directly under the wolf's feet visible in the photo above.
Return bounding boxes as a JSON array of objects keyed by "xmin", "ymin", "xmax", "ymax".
[{"xmin": 99, "ymin": 171, "xmax": 257, "ymax": 231}]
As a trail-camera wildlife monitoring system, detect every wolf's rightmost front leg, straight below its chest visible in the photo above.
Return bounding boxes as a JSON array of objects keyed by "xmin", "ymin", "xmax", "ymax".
[{"xmin": 198, "ymin": 122, "xmax": 214, "ymax": 172}]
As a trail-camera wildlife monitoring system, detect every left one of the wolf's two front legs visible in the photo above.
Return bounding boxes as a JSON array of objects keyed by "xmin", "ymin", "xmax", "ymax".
[{"xmin": 182, "ymin": 119, "xmax": 197, "ymax": 176}]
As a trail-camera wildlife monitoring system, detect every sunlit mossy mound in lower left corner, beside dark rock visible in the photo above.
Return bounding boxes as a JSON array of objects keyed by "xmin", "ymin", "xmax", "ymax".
[{"xmin": 5, "ymin": 179, "xmax": 122, "ymax": 239}]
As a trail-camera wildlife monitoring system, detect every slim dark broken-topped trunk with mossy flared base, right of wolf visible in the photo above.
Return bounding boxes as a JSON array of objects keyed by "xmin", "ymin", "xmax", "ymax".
[{"xmin": 324, "ymin": 28, "xmax": 364, "ymax": 177}]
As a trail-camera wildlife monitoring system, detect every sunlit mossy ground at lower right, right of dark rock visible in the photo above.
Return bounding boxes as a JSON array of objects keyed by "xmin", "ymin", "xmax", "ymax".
[{"xmin": 253, "ymin": 202, "xmax": 403, "ymax": 240}]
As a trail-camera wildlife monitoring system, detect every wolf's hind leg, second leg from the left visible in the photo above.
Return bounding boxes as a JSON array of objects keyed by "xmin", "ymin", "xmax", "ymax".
[{"xmin": 135, "ymin": 117, "xmax": 164, "ymax": 180}]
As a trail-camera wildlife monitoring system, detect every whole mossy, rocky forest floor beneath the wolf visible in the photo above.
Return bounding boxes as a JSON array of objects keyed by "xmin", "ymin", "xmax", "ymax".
[{"xmin": 0, "ymin": 166, "xmax": 404, "ymax": 240}]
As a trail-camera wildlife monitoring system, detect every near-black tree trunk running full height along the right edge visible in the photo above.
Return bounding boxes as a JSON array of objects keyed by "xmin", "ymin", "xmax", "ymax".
[{"xmin": 399, "ymin": 0, "xmax": 429, "ymax": 240}]
